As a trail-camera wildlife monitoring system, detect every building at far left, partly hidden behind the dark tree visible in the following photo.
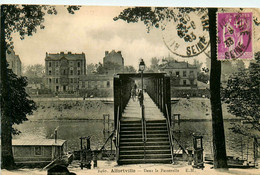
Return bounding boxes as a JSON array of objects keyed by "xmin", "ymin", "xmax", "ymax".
[{"xmin": 6, "ymin": 49, "xmax": 22, "ymax": 76}]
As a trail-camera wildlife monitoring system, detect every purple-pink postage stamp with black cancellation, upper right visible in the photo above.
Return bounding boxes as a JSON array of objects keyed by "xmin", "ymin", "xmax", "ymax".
[{"xmin": 217, "ymin": 12, "xmax": 253, "ymax": 60}]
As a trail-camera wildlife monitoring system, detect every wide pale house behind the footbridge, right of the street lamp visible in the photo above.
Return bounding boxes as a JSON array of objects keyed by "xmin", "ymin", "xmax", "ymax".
[{"xmin": 161, "ymin": 61, "xmax": 197, "ymax": 89}]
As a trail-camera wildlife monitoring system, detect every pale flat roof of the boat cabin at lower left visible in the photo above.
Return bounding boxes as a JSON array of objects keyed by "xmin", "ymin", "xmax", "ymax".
[{"xmin": 12, "ymin": 139, "xmax": 66, "ymax": 146}]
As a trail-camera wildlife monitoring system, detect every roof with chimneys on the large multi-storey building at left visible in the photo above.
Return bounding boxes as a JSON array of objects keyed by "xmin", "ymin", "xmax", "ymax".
[{"xmin": 45, "ymin": 52, "xmax": 85, "ymax": 61}]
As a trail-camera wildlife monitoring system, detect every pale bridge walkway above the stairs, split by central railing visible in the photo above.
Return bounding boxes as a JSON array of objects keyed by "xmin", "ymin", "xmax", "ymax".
[{"xmin": 122, "ymin": 92, "xmax": 165, "ymax": 120}]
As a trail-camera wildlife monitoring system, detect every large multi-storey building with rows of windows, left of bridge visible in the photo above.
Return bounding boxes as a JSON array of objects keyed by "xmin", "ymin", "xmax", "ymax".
[{"xmin": 45, "ymin": 52, "xmax": 86, "ymax": 92}]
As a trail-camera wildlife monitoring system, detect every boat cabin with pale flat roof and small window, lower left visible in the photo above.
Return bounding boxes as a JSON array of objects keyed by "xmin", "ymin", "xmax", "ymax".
[{"xmin": 12, "ymin": 139, "xmax": 67, "ymax": 164}]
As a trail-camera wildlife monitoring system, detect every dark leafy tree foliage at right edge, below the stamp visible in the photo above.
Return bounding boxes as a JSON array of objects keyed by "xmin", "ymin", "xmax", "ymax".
[{"xmin": 222, "ymin": 52, "xmax": 260, "ymax": 137}]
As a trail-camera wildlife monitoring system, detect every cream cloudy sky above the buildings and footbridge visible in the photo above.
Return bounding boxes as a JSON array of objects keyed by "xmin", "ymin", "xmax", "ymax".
[{"xmin": 10, "ymin": 6, "xmax": 260, "ymax": 68}]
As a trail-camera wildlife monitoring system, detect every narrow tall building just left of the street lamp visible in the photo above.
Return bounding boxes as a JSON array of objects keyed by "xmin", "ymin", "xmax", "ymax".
[{"xmin": 103, "ymin": 50, "xmax": 124, "ymax": 75}]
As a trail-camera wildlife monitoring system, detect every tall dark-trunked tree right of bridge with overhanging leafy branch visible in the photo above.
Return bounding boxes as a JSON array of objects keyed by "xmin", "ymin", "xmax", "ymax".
[{"xmin": 114, "ymin": 7, "xmax": 227, "ymax": 168}]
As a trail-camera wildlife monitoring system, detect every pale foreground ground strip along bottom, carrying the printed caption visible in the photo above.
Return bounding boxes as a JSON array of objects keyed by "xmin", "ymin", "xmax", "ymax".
[{"xmin": 2, "ymin": 161, "xmax": 259, "ymax": 175}]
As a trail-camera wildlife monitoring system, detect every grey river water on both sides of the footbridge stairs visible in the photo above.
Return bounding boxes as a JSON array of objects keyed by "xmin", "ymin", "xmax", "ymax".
[{"xmin": 14, "ymin": 120, "xmax": 253, "ymax": 160}]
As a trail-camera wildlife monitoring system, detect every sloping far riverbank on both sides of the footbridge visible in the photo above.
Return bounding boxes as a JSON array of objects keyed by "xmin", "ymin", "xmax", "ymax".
[{"xmin": 28, "ymin": 98, "xmax": 237, "ymax": 121}]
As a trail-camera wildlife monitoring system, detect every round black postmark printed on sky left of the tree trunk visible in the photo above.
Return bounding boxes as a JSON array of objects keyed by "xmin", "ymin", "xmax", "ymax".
[{"xmin": 163, "ymin": 9, "xmax": 209, "ymax": 57}]
